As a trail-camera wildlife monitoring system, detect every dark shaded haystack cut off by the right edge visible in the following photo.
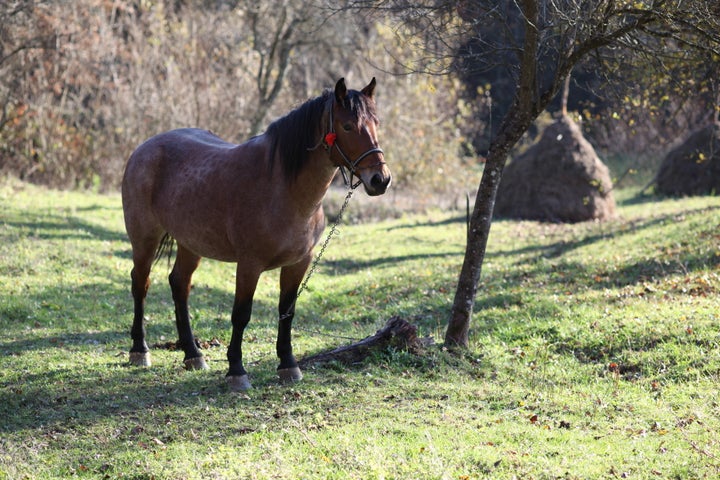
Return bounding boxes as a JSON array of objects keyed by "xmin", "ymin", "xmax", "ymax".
[{"xmin": 655, "ymin": 124, "xmax": 720, "ymax": 197}]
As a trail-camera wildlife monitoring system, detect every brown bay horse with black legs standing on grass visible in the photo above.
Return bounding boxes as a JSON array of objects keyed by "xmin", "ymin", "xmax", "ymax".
[{"xmin": 122, "ymin": 78, "xmax": 391, "ymax": 390}]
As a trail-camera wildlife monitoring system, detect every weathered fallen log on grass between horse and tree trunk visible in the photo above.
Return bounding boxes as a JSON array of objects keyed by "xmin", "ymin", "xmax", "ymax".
[{"xmin": 298, "ymin": 317, "xmax": 434, "ymax": 368}]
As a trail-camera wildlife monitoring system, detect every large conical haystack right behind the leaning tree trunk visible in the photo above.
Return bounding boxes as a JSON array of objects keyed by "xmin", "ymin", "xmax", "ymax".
[{"xmin": 495, "ymin": 116, "xmax": 615, "ymax": 222}]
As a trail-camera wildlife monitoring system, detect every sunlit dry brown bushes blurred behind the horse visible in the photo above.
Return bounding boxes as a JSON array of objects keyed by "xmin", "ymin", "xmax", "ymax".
[{"xmin": 0, "ymin": 0, "xmax": 475, "ymax": 199}]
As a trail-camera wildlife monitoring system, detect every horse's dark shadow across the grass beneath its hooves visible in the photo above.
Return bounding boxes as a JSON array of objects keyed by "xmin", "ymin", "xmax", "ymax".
[{"xmin": 0, "ymin": 332, "xmax": 416, "ymax": 438}]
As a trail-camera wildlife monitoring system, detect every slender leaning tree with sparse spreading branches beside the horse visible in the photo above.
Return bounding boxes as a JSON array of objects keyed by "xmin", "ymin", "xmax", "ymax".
[{"xmin": 354, "ymin": 0, "xmax": 720, "ymax": 347}]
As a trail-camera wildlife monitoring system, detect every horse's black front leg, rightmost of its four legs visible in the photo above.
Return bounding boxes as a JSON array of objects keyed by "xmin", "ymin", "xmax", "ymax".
[{"xmin": 276, "ymin": 255, "xmax": 312, "ymax": 383}]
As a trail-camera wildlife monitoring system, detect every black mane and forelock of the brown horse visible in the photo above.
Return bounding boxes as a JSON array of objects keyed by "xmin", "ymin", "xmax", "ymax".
[{"xmin": 265, "ymin": 85, "xmax": 377, "ymax": 181}]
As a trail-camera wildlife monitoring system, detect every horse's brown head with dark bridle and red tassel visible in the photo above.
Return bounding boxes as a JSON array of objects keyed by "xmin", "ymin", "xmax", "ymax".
[{"xmin": 325, "ymin": 78, "xmax": 392, "ymax": 196}]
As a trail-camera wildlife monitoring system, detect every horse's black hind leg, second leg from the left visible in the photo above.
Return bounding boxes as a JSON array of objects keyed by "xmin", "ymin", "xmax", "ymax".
[{"xmin": 168, "ymin": 245, "xmax": 208, "ymax": 370}]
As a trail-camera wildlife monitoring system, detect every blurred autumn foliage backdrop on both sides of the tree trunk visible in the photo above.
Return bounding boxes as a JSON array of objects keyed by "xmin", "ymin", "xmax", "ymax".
[{"xmin": 0, "ymin": 0, "xmax": 714, "ymax": 199}]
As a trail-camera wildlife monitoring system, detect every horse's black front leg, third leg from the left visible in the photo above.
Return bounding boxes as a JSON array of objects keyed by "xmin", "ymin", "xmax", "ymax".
[{"xmin": 225, "ymin": 265, "xmax": 260, "ymax": 391}]
